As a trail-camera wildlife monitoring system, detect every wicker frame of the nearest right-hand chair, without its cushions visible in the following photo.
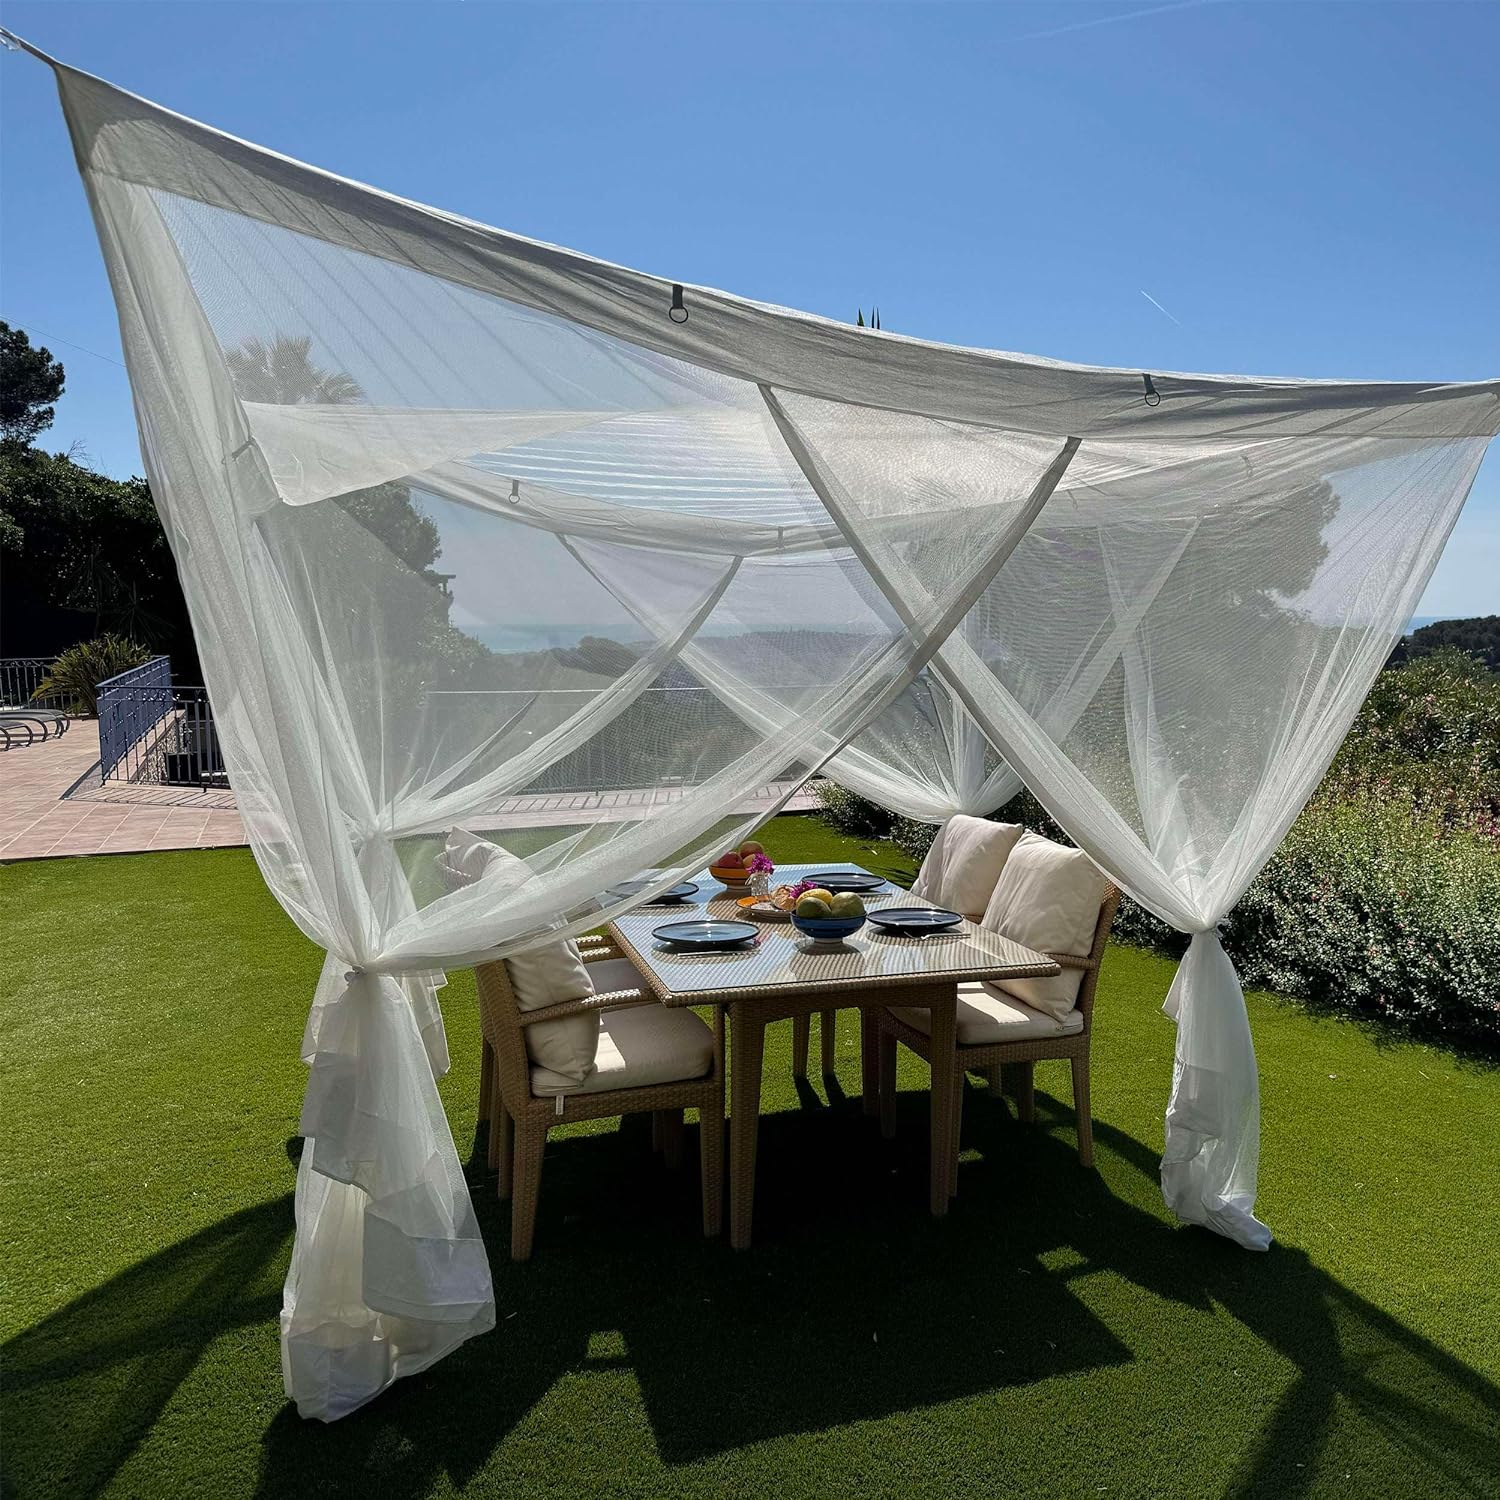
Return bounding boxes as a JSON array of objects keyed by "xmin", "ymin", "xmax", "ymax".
[{"xmin": 875, "ymin": 885, "xmax": 1121, "ymax": 1196}]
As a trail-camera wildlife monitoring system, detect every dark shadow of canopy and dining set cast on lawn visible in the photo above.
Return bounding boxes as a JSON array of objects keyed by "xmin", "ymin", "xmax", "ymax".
[{"xmin": 5, "ymin": 1092, "xmax": 1500, "ymax": 1497}]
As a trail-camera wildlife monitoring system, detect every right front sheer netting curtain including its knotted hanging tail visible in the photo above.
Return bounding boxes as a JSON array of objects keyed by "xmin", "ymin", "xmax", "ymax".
[{"xmin": 941, "ymin": 440, "xmax": 1484, "ymax": 1248}]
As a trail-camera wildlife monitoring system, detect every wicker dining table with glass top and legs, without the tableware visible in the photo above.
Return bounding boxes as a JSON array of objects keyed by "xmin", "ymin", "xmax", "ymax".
[{"xmin": 609, "ymin": 863, "xmax": 1061, "ymax": 1250}]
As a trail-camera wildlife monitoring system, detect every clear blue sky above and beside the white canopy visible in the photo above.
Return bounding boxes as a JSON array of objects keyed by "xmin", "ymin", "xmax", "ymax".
[{"xmin": 0, "ymin": 0, "xmax": 1500, "ymax": 615}]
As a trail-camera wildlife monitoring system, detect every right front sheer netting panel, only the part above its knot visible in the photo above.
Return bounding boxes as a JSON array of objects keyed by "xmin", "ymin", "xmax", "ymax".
[{"xmin": 950, "ymin": 423, "xmax": 1484, "ymax": 921}]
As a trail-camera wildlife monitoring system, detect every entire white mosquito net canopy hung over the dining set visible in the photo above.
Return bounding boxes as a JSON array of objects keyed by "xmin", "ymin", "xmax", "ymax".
[{"xmin": 14, "ymin": 32, "xmax": 1500, "ymax": 1419}]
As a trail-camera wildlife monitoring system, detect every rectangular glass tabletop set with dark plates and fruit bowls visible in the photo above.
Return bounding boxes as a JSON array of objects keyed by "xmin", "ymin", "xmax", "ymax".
[{"xmin": 609, "ymin": 861, "xmax": 1059, "ymax": 1005}]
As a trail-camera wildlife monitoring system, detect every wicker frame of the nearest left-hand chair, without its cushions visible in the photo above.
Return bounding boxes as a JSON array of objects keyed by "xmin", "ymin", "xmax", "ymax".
[{"xmin": 474, "ymin": 938, "xmax": 725, "ymax": 1260}]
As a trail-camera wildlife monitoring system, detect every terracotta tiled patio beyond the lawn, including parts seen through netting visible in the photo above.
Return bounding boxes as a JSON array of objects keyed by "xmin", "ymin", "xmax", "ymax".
[{"xmin": 0, "ymin": 720, "xmax": 816, "ymax": 861}]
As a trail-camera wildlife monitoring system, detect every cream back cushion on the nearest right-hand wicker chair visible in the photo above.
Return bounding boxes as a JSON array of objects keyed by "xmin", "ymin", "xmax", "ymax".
[{"xmin": 981, "ymin": 833, "xmax": 1109, "ymax": 1020}]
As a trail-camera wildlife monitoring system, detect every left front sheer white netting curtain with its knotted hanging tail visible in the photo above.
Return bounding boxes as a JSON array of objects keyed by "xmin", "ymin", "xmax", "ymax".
[{"xmin": 126, "ymin": 175, "xmax": 984, "ymax": 1419}]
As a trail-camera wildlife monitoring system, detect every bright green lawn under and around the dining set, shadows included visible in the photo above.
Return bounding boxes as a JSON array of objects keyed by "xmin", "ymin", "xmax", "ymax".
[{"xmin": 0, "ymin": 819, "xmax": 1500, "ymax": 1500}]
